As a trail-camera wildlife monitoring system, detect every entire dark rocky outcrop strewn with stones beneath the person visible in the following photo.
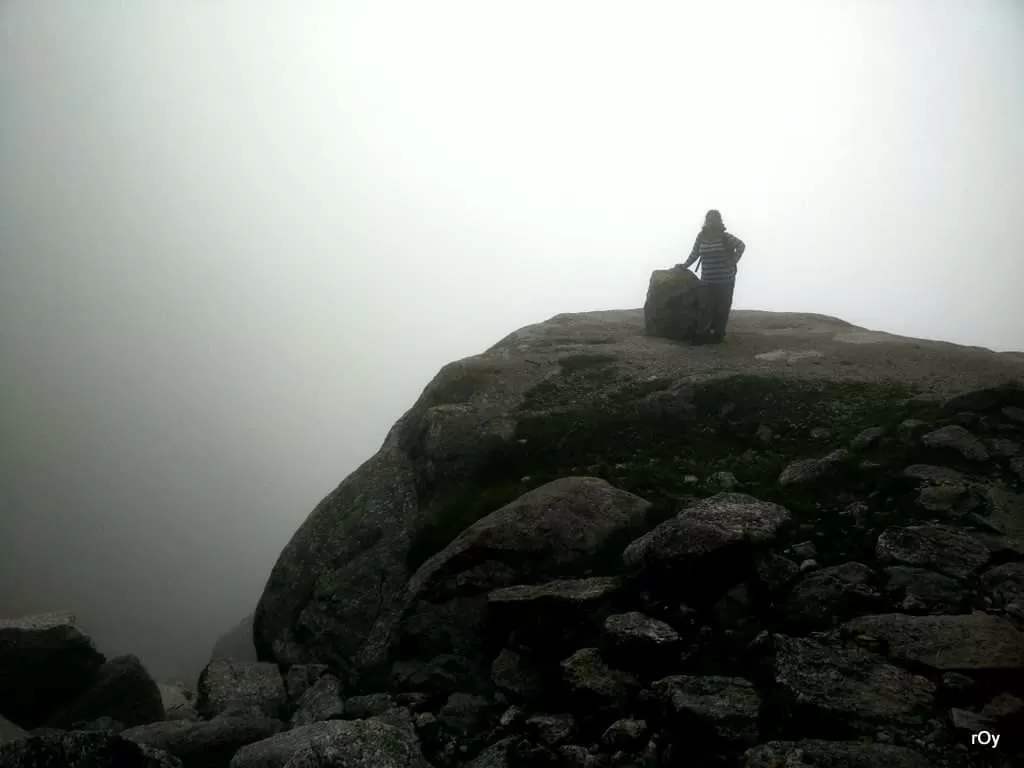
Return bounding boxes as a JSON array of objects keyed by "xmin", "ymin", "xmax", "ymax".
[{"xmin": 235, "ymin": 312, "xmax": 1024, "ymax": 768}]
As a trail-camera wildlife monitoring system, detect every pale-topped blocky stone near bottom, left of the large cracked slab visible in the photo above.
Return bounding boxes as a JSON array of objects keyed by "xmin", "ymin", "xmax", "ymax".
[{"xmin": 651, "ymin": 675, "xmax": 761, "ymax": 745}]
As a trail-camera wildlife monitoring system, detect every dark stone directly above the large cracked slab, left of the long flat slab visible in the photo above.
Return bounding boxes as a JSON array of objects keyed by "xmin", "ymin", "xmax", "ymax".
[{"xmin": 782, "ymin": 562, "xmax": 882, "ymax": 630}]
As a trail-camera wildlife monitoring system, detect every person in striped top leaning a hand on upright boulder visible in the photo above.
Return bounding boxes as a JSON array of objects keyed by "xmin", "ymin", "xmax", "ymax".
[{"xmin": 676, "ymin": 210, "xmax": 746, "ymax": 344}]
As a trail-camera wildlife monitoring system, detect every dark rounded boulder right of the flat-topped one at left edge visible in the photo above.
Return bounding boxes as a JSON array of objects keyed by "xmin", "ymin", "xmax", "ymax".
[{"xmin": 47, "ymin": 655, "xmax": 166, "ymax": 728}]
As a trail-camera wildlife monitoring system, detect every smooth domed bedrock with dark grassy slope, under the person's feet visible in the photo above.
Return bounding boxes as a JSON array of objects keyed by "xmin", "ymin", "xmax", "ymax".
[{"xmin": 254, "ymin": 310, "xmax": 1024, "ymax": 677}]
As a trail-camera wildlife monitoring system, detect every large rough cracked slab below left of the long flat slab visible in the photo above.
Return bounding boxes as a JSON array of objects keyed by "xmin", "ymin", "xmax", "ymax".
[{"xmin": 772, "ymin": 635, "xmax": 935, "ymax": 732}]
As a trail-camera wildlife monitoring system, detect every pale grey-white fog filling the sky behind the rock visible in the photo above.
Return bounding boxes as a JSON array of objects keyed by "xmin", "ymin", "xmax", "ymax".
[{"xmin": 0, "ymin": 0, "xmax": 1024, "ymax": 677}]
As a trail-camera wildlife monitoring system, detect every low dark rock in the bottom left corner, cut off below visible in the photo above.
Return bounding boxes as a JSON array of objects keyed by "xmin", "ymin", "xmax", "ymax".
[{"xmin": 0, "ymin": 731, "xmax": 182, "ymax": 768}]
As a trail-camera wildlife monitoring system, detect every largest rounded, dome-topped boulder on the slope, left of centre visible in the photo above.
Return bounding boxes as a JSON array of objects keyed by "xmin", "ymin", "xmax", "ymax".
[{"xmin": 400, "ymin": 477, "xmax": 650, "ymax": 657}]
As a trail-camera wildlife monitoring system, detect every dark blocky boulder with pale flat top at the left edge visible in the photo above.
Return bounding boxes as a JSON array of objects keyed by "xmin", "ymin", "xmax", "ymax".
[{"xmin": 0, "ymin": 612, "xmax": 105, "ymax": 728}]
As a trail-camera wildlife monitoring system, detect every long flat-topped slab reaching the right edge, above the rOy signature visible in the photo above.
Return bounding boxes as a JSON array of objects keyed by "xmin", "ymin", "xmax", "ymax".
[{"xmin": 846, "ymin": 613, "xmax": 1024, "ymax": 672}]
